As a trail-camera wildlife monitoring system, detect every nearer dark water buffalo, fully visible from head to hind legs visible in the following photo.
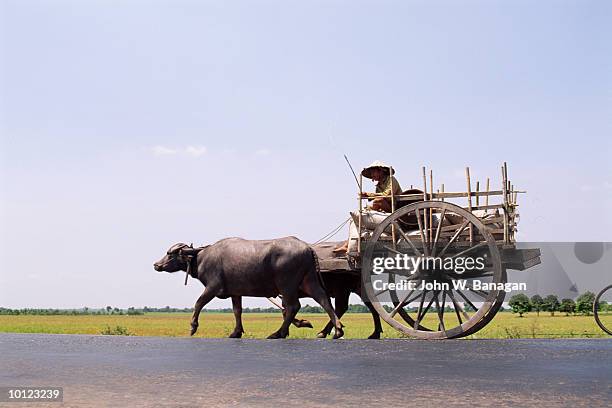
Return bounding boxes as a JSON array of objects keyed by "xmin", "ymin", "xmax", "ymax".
[{"xmin": 153, "ymin": 237, "xmax": 343, "ymax": 338}]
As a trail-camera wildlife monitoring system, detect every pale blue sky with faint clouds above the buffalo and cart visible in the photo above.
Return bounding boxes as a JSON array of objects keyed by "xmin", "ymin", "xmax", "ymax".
[{"xmin": 0, "ymin": 0, "xmax": 612, "ymax": 307}]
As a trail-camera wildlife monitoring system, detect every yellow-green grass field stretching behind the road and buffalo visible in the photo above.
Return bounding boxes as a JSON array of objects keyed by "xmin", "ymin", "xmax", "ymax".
[{"xmin": 0, "ymin": 312, "xmax": 612, "ymax": 339}]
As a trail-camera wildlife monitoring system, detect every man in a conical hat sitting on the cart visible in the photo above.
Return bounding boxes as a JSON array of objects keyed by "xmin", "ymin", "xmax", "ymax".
[{"xmin": 334, "ymin": 160, "xmax": 402, "ymax": 254}]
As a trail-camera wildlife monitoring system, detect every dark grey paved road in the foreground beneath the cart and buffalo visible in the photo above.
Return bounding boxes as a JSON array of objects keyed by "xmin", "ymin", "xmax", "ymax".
[{"xmin": 0, "ymin": 334, "xmax": 612, "ymax": 407}]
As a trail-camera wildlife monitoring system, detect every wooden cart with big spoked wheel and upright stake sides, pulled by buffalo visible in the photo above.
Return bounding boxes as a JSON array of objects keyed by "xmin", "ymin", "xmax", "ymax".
[{"xmin": 315, "ymin": 163, "xmax": 540, "ymax": 339}]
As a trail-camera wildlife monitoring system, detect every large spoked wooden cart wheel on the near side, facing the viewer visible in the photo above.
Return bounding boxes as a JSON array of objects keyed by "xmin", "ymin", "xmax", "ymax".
[{"xmin": 362, "ymin": 201, "xmax": 506, "ymax": 339}]
